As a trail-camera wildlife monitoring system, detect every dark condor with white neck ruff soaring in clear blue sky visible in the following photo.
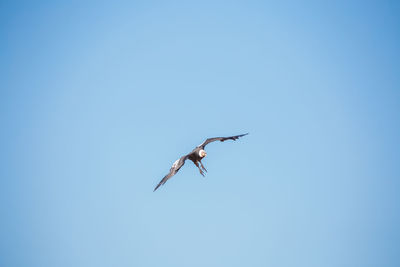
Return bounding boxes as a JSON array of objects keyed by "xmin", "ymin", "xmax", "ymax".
[{"xmin": 153, "ymin": 133, "xmax": 249, "ymax": 192}]
